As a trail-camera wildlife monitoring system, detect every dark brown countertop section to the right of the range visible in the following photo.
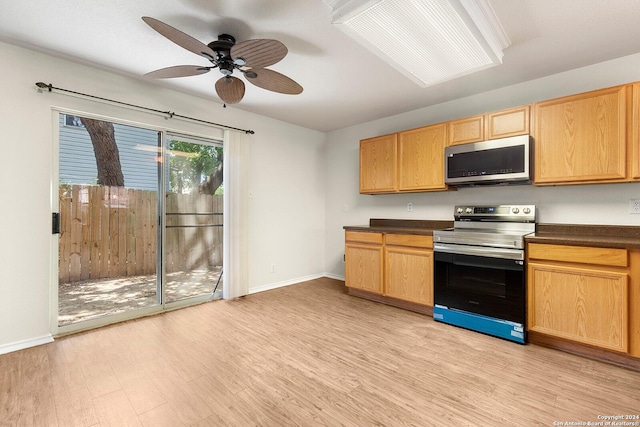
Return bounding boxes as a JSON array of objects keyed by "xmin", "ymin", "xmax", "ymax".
[{"xmin": 525, "ymin": 224, "xmax": 640, "ymax": 249}]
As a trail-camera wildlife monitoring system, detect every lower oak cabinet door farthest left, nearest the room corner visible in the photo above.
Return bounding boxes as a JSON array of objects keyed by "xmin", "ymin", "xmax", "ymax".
[{"xmin": 345, "ymin": 243, "xmax": 383, "ymax": 294}]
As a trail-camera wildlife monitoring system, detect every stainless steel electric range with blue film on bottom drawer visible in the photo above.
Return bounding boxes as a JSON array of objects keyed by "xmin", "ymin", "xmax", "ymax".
[{"xmin": 433, "ymin": 205, "xmax": 536, "ymax": 344}]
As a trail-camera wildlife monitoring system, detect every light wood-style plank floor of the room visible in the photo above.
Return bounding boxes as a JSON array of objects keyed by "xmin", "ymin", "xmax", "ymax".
[{"xmin": 0, "ymin": 278, "xmax": 640, "ymax": 427}]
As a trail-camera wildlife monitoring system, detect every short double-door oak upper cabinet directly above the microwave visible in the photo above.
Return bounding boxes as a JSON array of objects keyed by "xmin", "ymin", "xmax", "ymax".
[{"xmin": 447, "ymin": 105, "xmax": 531, "ymax": 145}]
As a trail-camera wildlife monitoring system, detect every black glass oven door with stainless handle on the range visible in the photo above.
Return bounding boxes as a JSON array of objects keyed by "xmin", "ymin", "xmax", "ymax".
[{"xmin": 434, "ymin": 244, "xmax": 525, "ymax": 325}]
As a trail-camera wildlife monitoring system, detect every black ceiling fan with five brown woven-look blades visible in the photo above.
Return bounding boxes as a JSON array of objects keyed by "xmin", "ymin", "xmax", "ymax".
[{"xmin": 142, "ymin": 16, "xmax": 302, "ymax": 106}]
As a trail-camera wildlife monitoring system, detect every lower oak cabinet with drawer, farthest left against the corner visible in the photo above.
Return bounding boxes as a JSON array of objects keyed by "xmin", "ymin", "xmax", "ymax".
[{"xmin": 344, "ymin": 231, "xmax": 383, "ymax": 294}]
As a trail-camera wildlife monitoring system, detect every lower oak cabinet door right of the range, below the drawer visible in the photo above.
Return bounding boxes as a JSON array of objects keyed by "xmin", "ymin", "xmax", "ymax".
[{"xmin": 527, "ymin": 263, "xmax": 628, "ymax": 352}]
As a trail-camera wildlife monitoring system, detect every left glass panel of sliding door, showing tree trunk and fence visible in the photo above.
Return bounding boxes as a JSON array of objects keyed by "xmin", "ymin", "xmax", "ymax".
[{"xmin": 58, "ymin": 114, "xmax": 160, "ymax": 326}]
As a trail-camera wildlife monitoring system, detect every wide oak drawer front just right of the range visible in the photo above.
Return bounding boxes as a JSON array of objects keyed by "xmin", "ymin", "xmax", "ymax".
[{"xmin": 527, "ymin": 243, "xmax": 629, "ymax": 267}]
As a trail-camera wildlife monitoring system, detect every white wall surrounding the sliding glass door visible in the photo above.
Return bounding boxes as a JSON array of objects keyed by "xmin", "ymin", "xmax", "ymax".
[{"xmin": 0, "ymin": 43, "xmax": 325, "ymax": 353}]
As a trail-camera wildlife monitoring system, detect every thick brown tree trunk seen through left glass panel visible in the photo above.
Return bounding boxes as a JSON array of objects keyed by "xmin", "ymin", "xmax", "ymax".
[{"xmin": 80, "ymin": 117, "xmax": 124, "ymax": 187}]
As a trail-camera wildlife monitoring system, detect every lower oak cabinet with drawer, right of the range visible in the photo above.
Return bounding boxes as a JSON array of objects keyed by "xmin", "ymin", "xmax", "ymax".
[{"xmin": 527, "ymin": 243, "xmax": 630, "ymax": 353}]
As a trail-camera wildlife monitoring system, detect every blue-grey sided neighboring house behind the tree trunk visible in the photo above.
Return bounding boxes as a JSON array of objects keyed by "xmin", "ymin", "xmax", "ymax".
[{"xmin": 59, "ymin": 114, "xmax": 158, "ymax": 191}]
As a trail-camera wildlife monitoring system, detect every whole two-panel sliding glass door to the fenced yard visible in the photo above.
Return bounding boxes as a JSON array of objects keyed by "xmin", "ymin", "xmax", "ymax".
[{"xmin": 54, "ymin": 113, "xmax": 223, "ymax": 332}]
